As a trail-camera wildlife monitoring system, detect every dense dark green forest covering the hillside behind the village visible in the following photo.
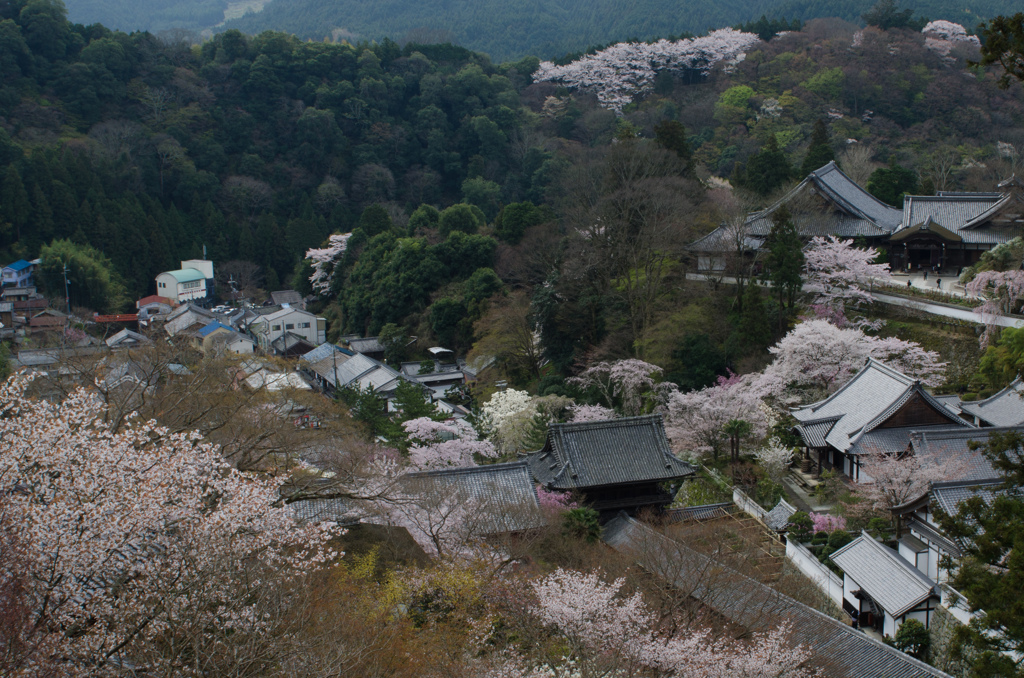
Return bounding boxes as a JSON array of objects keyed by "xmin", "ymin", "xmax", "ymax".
[{"xmin": 0, "ymin": 0, "xmax": 1024, "ymax": 385}]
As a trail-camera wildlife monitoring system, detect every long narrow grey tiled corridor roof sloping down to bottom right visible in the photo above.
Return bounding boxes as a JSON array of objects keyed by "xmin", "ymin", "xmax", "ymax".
[{"xmin": 604, "ymin": 514, "xmax": 948, "ymax": 678}]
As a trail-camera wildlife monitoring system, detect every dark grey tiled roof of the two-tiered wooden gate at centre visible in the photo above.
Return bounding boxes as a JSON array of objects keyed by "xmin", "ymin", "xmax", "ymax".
[{"xmin": 528, "ymin": 415, "xmax": 693, "ymax": 491}]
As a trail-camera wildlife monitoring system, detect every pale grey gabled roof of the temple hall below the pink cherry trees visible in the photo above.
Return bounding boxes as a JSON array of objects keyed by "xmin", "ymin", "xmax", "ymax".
[{"xmin": 793, "ymin": 358, "xmax": 970, "ymax": 452}]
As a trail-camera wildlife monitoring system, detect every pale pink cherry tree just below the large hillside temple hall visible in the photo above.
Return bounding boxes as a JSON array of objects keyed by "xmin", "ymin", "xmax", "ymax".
[{"xmin": 804, "ymin": 236, "xmax": 891, "ymax": 327}]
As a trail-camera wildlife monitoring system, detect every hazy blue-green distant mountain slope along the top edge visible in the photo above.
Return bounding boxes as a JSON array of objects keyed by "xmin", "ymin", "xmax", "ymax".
[{"xmin": 68, "ymin": 0, "xmax": 1020, "ymax": 61}]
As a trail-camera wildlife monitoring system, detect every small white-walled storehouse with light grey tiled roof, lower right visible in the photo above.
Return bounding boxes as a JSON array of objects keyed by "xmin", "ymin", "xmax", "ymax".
[{"xmin": 828, "ymin": 532, "xmax": 942, "ymax": 637}]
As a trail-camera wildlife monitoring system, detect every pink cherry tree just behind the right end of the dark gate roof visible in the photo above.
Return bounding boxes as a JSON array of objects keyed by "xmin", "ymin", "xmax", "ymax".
[{"xmin": 666, "ymin": 374, "xmax": 767, "ymax": 459}]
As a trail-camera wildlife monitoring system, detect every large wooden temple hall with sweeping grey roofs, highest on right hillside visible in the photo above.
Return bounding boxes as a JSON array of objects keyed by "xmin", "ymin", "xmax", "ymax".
[{"xmin": 690, "ymin": 162, "xmax": 1024, "ymax": 274}]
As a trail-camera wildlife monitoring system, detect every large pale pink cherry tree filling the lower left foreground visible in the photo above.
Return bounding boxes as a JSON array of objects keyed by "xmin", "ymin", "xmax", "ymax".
[{"xmin": 0, "ymin": 378, "xmax": 331, "ymax": 676}]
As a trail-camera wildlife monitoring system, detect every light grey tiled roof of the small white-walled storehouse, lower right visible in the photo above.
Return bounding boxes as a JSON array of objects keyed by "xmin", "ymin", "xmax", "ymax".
[{"xmin": 828, "ymin": 533, "xmax": 939, "ymax": 618}]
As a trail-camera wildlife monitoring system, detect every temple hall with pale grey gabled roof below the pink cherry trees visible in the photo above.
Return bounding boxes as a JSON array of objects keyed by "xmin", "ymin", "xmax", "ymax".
[{"xmin": 792, "ymin": 358, "xmax": 972, "ymax": 481}]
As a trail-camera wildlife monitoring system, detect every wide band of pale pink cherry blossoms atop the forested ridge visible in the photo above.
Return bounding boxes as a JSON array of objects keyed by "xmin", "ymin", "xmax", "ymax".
[{"xmin": 534, "ymin": 29, "xmax": 759, "ymax": 112}]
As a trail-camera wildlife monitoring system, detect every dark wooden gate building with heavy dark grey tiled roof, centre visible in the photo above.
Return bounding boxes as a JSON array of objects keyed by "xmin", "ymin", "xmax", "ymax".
[{"xmin": 527, "ymin": 415, "xmax": 694, "ymax": 512}]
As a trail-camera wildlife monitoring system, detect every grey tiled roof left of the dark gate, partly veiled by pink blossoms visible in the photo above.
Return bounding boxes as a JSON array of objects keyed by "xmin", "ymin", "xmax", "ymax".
[{"xmin": 403, "ymin": 461, "xmax": 545, "ymax": 535}]
